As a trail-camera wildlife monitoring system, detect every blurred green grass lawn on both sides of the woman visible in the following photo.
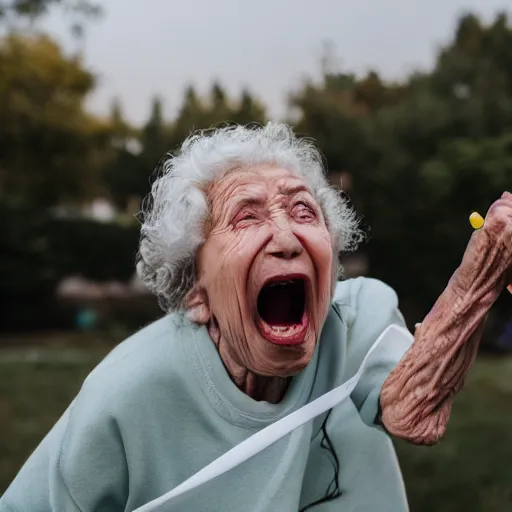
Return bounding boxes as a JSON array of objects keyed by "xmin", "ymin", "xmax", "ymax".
[{"xmin": 0, "ymin": 334, "xmax": 512, "ymax": 512}]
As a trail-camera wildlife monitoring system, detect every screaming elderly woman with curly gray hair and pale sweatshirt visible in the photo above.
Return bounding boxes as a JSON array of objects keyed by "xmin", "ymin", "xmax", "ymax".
[{"xmin": 0, "ymin": 124, "xmax": 512, "ymax": 512}]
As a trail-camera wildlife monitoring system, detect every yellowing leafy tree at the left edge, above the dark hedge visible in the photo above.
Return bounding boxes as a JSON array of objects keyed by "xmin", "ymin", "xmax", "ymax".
[{"xmin": 0, "ymin": 36, "xmax": 108, "ymax": 209}]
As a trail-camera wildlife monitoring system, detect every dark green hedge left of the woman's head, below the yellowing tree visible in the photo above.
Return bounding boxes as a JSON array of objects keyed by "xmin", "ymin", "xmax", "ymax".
[{"xmin": 0, "ymin": 205, "xmax": 139, "ymax": 331}]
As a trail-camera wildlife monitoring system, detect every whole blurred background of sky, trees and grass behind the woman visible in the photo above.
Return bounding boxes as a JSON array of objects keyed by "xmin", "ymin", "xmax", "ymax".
[{"xmin": 0, "ymin": 0, "xmax": 512, "ymax": 512}]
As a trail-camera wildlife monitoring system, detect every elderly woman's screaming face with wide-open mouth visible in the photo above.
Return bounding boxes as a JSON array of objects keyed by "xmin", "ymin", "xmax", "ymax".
[{"xmin": 197, "ymin": 167, "xmax": 333, "ymax": 377}]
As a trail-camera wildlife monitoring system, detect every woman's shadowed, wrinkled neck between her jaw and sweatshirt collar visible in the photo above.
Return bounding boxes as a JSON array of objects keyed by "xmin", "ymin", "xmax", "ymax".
[{"xmin": 208, "ymin": 322, "xmax": 290, "ymax": 404}]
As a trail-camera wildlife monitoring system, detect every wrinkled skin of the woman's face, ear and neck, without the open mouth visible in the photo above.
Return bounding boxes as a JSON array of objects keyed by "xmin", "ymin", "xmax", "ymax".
[{"xmin": 188, "ymin": 166, "xmax": 333, "ymax": 403}]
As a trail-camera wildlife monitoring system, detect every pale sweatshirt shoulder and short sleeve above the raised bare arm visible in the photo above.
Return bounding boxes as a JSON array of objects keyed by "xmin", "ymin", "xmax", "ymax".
[{"xmin": 335, "ymin": 278, "xmax": 412, "ymax": 427}]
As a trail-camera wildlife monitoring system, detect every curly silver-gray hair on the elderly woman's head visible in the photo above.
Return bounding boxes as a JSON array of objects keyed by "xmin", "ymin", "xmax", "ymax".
[{"xmin": 137, "ymin": 122, "xmax": 363, "ymax": 312}]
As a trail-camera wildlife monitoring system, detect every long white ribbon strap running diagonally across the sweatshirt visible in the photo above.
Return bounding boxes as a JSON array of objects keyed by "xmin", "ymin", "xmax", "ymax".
[{"xmin": 133, "ymin": 325, "xmax": 413, "ymax": 512}]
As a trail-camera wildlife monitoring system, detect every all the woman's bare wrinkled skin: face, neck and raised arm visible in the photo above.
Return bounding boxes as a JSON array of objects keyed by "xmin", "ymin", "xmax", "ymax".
[{"xmin": 188, "ymin": 158, "xmax": 512, "ymax": 438}]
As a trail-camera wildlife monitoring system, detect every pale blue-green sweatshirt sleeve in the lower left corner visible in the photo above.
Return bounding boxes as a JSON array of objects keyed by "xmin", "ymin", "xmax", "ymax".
[{"xmin": 0, "ymin": 389, "xmax": 128, "ymax": 512}]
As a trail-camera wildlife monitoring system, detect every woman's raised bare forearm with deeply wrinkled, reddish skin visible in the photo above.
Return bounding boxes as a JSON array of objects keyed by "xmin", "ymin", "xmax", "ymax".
[{"xmin": 380, "ymin": 192, "xmax": 512, "ymax": 445}]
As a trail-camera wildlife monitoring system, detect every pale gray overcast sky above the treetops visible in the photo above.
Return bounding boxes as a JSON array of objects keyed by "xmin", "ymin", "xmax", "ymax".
[{"xmin": 44, "ymin": 0, "xmax": 512, "ymax": 123}]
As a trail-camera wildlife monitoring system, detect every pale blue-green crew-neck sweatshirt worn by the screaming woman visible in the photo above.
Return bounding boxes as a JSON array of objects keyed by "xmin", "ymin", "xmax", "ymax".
[{"xmin": 0, "ymin": 278, "xmax": 408, "ymax": 512}]
